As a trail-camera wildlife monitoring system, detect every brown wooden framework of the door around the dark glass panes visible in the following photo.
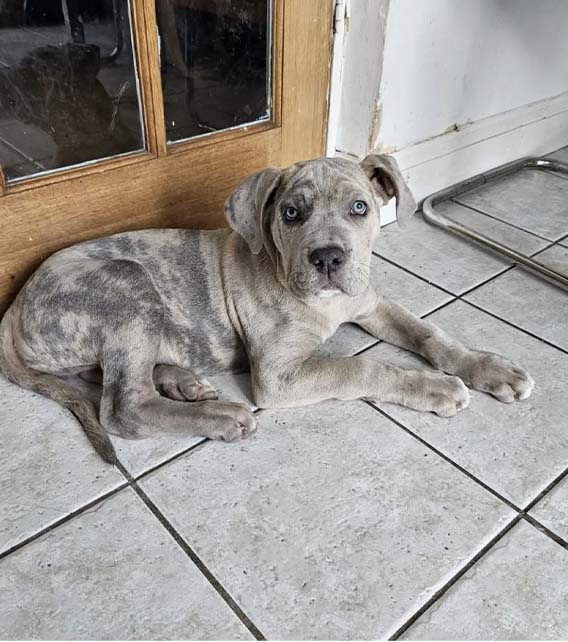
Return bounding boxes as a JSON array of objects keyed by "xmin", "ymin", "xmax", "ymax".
[{"xmin": 0, "ymin": 0, "xmax": 334, "ymax": 312}]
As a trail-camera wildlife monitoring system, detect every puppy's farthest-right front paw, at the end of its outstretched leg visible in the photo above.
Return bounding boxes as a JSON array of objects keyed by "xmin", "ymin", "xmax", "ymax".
[{"xmin": 464, "ymin": 352, "xmax": 534, "ymax": 403}]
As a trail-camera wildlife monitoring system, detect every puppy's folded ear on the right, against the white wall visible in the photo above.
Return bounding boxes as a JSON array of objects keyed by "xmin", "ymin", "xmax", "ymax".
[{"xmin": 361, "ymin": 154, "xmax": 416, "ymax": 225}]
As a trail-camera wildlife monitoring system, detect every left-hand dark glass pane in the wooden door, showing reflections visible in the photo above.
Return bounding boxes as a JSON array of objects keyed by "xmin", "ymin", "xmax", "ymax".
[{"xmin": 0, "ymin": 0, "xmax": 144, "ymax": 181}]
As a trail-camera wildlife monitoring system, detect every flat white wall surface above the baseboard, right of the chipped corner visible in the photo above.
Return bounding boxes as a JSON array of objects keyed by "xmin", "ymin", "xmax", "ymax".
[{"xmin": 373, "ymin": 0, "xmax": 568, "ymax": 148}]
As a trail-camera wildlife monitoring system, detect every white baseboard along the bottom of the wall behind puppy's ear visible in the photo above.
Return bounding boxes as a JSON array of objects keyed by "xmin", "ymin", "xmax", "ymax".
[{"xmin": 362, "ymin": 92, "xmax": 568, "ymax": 225}]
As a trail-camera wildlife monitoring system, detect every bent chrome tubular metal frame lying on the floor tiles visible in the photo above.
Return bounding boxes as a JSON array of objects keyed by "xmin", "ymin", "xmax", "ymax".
[{"xmin": 422, "ymin": 158, "xmax": 568, "ymax": 290}]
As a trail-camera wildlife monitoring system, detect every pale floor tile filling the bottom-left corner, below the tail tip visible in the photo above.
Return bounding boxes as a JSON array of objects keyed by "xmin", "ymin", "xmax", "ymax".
[{"xmin": 0, "ymin": 489, "xmax": 252, "ymax": 640}]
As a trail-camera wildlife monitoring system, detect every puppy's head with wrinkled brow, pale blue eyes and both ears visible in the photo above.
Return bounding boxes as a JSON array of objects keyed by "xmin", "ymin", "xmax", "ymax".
[{"xmin": 225, "ymin": 154, "xmax": 416, "ymax": 300}]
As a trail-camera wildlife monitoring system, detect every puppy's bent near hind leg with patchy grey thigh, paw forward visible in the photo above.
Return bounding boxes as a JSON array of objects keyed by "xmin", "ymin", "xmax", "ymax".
[{"xmin": 95, "ymin": 261, "xmax": 256, "ymax": 441}]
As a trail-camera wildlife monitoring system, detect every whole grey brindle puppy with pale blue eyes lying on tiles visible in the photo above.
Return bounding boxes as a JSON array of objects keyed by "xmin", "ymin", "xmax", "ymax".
[{"xmin": 0, "ymin": 155, "xmax": 534, "ymax": 462}]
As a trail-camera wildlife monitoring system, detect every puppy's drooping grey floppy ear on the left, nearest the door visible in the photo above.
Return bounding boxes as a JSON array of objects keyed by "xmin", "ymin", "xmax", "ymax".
[{"xmin": 225, "ymin": 167, "xmax": 282, "ymax": 254}]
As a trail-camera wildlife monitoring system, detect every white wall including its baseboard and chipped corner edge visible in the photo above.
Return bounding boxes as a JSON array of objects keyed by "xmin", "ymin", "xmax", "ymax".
[{"xmin": 332, "ymin": 0, "xmax": 568, "ymax": 212}]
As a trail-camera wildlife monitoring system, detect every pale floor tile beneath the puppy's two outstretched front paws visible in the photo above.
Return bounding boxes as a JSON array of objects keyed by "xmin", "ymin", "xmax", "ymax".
[{"xmin": 366, "ymin": 301, "xmax": 568, "ymax": 507}]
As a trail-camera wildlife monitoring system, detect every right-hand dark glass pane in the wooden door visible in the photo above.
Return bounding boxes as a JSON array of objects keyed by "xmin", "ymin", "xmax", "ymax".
[{"xmin": 156, "ymin": 0, "xmax": 271, "ymax": 141}]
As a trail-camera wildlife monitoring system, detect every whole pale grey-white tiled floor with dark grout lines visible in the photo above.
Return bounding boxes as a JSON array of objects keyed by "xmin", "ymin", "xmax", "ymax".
[{"xmin": 0, "ymin": 151, "xmax": 568, "ymax": 639}]
